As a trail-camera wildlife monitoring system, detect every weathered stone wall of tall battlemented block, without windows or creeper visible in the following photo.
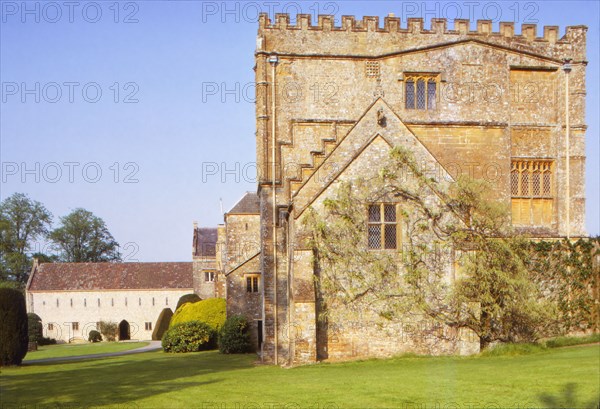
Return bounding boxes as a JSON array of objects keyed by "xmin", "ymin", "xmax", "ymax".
[{"xmin": 256, "ymin": 15, "xmax": 587, "ymax": 364}]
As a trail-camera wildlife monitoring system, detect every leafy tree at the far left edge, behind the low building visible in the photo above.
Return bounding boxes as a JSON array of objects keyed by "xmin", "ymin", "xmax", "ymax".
[{"xmin": 0, "ymin": 193, "xmax": 52, "ymax": 286}]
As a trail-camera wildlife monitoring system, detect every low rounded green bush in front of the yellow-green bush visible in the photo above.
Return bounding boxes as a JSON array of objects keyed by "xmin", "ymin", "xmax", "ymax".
[{"xmin": 162, "ymin": 321, "xmax": 216, "ymax": 352}]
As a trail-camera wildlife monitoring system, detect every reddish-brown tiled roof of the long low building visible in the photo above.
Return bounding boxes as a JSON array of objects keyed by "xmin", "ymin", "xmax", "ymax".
[{"xmin": 28, "ymin": 263, "xmax": 194, "ymax": 291}]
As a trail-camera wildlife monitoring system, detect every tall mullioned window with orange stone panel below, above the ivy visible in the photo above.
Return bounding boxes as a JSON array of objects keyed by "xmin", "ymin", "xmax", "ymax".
[{"xmin": 509, "ymin": 158, "xmax": 555, "ymax": 227}]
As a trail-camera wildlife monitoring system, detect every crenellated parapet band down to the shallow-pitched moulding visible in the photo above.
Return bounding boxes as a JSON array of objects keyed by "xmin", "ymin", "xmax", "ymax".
[{"xmin": 258, "ymin": 13, "xmax": 587, "ymax": 62}]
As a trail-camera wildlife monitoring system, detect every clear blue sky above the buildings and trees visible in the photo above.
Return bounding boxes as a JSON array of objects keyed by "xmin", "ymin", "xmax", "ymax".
[{"xmin": 0, "ymin": 1, "xmax": 600, "ymax": 261}]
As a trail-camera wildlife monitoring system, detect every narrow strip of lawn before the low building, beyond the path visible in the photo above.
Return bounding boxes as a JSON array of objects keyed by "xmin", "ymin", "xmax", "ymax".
[{"xmin": 25, "ymin": 342, "xmax": 148, "ymax": 361}]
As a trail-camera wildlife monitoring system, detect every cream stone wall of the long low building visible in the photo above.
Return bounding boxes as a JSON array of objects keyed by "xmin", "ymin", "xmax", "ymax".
[{"xmin": 28, "ymin": 288, "xmax": 193, "ymax": 342}]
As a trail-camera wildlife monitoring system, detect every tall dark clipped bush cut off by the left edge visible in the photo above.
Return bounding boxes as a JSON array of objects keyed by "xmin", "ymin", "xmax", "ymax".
[{"xmin": 0, "ymin": 288, "xmax": 29, "ymax": 366}]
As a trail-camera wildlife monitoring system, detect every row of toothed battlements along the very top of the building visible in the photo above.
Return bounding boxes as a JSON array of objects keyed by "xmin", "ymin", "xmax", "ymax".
[{"xmin": 259, "ymin": 13, "xmax": 587, "ymax": 44}]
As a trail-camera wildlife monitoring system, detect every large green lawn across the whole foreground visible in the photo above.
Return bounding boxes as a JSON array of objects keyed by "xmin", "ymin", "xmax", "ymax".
[{"xmin": 0, "ymin": 345, "xmax": 600, "ymax": 409}]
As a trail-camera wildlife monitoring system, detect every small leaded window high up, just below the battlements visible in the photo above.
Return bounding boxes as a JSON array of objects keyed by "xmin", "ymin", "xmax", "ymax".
[{"xmin": 403, "ymin": 72, "xmax": 441, "ymax": 111}]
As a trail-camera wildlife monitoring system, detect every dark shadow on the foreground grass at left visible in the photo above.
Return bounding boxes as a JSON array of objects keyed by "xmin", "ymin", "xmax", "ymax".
[{"xmin": 2, "ymin": 351, "xmax": 253, "ymax": 408}]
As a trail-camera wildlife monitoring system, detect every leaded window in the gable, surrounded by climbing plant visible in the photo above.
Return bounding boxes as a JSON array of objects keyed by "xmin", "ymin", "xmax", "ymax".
[{"xmin": 366, "ymin": 202, "xmax": 402, "ymax": 251}]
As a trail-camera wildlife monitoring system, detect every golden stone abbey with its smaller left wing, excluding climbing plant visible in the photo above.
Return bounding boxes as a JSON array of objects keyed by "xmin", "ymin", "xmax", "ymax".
[{"xmin": 27, "ymin": 14, "xmax": 587, "ymax": 365}]
